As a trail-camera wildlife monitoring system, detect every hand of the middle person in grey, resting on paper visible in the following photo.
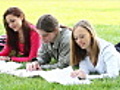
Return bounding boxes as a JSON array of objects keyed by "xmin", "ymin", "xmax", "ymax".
[{"xmin": 26, "ymin": 61, "xmax": 42, "ymax": 71}]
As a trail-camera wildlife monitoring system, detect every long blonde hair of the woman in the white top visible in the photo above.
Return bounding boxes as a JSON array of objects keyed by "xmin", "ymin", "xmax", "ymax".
[{"xmin": 70, "ymin": 20, "xmax": 99, "ymax": 66}]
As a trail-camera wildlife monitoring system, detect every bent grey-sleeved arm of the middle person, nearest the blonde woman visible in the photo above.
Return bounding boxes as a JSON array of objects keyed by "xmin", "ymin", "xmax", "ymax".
[{"xmin": 41, "ymin": 40, "xmax": 70, "ymax": 69}]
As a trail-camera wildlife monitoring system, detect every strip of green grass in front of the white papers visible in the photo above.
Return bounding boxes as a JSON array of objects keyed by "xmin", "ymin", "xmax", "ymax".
[{"xmin": 0, "ymin": 74, "xmax": 120, "ymax": 90}]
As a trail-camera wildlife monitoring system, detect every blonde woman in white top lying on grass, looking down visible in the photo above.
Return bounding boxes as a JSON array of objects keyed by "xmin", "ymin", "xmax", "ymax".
[{"xmin": 71, "ymin": 20, "xmax": 120, "ymax": 78}]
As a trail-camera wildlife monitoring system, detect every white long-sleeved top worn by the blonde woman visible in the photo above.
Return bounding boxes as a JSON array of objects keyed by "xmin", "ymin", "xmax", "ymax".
[{"xmin": 79, "ymin": 38, "xmax": 120, "ymax": 77}]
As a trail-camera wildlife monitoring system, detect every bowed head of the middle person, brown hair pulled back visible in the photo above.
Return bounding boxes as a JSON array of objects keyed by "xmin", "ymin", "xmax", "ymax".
[{"xmin": 37, "ymin": 14, "xmax": 59, "ymax": 43}]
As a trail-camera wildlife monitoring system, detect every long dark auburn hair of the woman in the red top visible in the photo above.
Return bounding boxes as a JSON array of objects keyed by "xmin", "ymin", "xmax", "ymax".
[{"xmin": 3, "ymin": 7, "xmax": 31, "ymax": 56}]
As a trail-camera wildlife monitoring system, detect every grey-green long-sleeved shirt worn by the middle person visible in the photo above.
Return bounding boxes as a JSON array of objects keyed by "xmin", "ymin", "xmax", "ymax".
[{"xmin": 37, "ymin": 28, "xmax": 71, "ymax": 69}]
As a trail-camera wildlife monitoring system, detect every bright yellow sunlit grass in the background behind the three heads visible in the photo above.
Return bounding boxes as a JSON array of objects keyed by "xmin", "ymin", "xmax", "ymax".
[{"xmin": 0, "ymin": 0, "xmax": 120, "ymax": 26}]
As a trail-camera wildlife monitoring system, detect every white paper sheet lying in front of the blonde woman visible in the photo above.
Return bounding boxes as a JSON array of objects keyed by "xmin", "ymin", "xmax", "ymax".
[{"xmin": 40, "ymin": 66, "xmax": 91, "ymax": 85}]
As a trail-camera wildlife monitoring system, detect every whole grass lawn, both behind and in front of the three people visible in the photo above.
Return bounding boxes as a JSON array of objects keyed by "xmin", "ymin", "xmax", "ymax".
[{"xmin": 0, "ymin": 0, "xmax": 120, "ymax": 90}]
